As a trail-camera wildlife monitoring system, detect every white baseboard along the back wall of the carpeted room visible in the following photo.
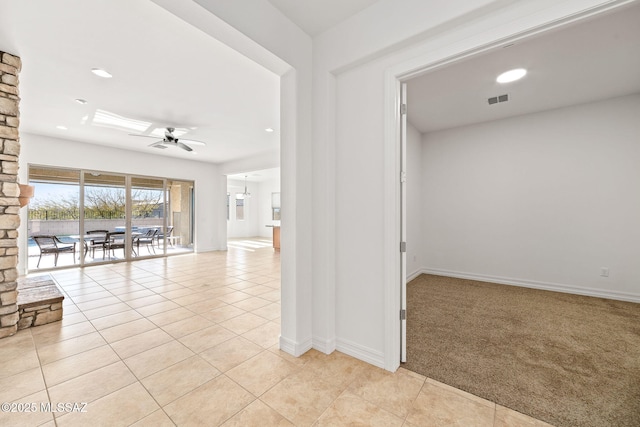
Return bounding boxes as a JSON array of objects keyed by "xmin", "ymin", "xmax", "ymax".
[{"xmin": 420, "ymin": 268, "xmax": 640, "ymax": 302}]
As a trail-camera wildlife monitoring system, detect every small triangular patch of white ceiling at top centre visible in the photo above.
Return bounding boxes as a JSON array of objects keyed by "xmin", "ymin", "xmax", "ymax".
[{"xmin": 269, "ymin": 0, "xmax": 378, "ymax": 36}]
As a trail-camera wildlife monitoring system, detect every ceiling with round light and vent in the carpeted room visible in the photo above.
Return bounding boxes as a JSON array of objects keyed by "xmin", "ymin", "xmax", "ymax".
[{"xmin": 407, "ymin": 2, "xmax": 640, "ymax": 133}]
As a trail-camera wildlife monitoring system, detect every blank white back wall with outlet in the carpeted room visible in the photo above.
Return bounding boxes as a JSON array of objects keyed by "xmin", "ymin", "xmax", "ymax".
[{"xmin": 421, "ymin": 94, "xmax": 640, "ymax": 301}]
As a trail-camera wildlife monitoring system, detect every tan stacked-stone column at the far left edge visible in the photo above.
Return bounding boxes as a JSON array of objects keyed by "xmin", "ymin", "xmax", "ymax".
[{"xmin": 0, "ymin": 51, "xmax": 22, "ymax": 338}]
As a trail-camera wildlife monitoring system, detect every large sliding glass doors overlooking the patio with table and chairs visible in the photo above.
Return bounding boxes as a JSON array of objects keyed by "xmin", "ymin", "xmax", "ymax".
[{"xmin": 27, "ymin": 165, "xmax": 194, "ymax": 270}]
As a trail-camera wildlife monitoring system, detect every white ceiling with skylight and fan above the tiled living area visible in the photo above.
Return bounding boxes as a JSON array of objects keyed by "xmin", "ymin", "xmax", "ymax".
[{"xmin": 0, "ymin": 0, "xmax": 280, "ymax": 163}]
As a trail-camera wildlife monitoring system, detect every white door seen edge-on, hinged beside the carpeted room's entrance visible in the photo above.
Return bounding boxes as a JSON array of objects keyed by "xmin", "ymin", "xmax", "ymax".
[{"xmin": 400, "ymin": 83, "xmax": 407, "ymax": 362}]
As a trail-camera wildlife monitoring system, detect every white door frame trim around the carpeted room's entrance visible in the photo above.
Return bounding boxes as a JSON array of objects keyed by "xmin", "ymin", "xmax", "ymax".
[{"xmin": 383, "ymin": 0, "xmax": 631, "ymax": 371}]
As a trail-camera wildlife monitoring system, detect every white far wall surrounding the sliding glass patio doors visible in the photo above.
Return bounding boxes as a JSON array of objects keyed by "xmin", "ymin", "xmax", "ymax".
[{"xmin": 18, "ymin": 132, "xmax": 226, "ymax": 274}]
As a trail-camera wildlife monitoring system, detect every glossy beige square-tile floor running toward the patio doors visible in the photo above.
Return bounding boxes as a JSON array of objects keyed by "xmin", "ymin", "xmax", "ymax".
[{"xmin": 0, "ymin": 241, "xmax": 545, "ymax": 427}]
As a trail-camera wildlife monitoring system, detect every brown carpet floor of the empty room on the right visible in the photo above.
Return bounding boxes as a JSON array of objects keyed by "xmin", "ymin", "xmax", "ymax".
[{"xmin": 404, "ymin": 275, "xmax": 640, "ymax": 427}]
